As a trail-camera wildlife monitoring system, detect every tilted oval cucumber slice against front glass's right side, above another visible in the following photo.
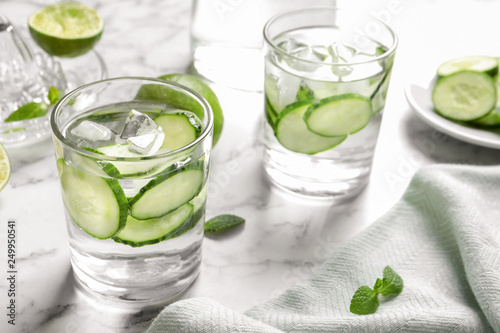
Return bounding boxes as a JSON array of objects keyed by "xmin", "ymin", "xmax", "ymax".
[{"xmin": 130, "ymin": 162, "xmax": 204, "ymax": 220}]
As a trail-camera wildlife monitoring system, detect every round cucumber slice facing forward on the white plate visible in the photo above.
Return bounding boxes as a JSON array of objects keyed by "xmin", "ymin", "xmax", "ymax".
[{"xmin": 432, "ymin": 71, "xmax": 497, "ymax": 121}]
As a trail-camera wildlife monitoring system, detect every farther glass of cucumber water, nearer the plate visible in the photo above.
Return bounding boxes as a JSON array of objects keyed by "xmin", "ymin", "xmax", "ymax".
[{"xmin": 263, "ymin": 7, "xmax": 397, "ymax": 200}]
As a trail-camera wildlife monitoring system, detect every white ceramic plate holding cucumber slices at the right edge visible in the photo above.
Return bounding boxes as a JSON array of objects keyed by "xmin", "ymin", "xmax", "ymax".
[{"xmin": 405, "ymin": 82, "xmax": 500, "ymax": 149}]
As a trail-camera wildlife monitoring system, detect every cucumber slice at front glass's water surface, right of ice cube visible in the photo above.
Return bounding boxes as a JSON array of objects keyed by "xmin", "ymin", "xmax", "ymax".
[{"xmin": 154, "ymin": 113, "xmax": 201, "ymax": 152}]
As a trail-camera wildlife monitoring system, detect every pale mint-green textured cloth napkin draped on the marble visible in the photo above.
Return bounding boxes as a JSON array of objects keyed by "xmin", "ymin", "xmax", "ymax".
[{"xmin": 148, "ymin": 165, "xmax": 500, "ymax": 333}]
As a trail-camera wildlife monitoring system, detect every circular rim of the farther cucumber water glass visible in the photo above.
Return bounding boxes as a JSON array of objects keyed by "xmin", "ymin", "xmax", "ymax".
[{"xmin": 263, "ymin": 6, "xmax": 399, "ymax": 66}]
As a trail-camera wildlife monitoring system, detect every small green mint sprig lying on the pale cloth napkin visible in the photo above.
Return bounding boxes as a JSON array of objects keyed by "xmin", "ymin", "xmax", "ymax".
[{"xmin": 349, "ymin": 266, "xmax": 404, "ymax": 315}]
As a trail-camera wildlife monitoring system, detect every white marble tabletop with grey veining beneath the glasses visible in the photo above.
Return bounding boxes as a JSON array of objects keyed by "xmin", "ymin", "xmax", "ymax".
[{"xmin": 0, "ymin": 0, "xmax": 500, "ymax": 332}]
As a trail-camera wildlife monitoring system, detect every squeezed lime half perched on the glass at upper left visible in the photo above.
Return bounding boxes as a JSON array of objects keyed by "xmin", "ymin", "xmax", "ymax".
[{"xmin": 28, "ymin": 2, "xmax": 104, "ymax": 58}]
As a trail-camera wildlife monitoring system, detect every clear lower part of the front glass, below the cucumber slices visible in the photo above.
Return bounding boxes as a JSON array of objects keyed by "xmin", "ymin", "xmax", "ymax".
[{"xmin": 67, "ymin": 216, "xmax": 205, "ymax": 305}]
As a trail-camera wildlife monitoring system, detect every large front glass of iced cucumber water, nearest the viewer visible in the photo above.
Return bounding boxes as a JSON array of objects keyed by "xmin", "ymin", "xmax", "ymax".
[{"xmin": 51, "ymin": 77, "xmax": 213, "ymax": 304}]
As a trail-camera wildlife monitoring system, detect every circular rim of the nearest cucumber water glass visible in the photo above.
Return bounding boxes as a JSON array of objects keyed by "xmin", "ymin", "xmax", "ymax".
[{"xmin": 50, "ymin": 76, "xmax": 214, "ymax": 162}]
